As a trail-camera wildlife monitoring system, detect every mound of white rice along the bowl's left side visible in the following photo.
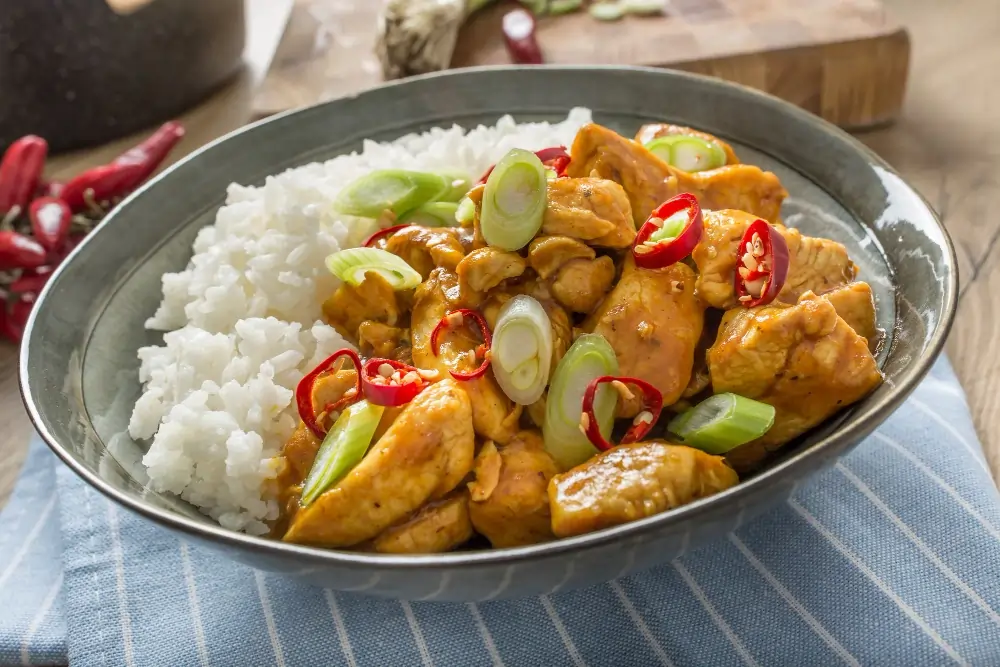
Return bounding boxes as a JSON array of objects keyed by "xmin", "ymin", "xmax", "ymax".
[{"xmin": 129, "ymin": 109, "xmax": 590, "ymax": 534}]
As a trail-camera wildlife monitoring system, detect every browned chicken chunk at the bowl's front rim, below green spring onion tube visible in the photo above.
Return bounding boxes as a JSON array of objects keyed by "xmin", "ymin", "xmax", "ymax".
[{"xmin": 549, "ymin": 440, "xmax": 739, "ymax": 537}]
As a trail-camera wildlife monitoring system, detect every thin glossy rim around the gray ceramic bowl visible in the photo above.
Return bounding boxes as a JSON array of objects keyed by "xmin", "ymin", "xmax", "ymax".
[{"xmin": 18, "ymin": 65, "xmax": 958, "ymax": 570}]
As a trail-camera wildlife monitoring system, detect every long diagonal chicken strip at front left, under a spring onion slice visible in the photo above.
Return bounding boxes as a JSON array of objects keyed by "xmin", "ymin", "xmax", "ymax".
[{"xmin": 283, "ymin": 379, "xmax": 475, "ymax": 548}]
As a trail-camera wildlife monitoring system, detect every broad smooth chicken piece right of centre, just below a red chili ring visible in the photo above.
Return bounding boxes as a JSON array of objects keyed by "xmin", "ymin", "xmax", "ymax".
[{"xmin": 583, "ymin": 254, "xmax": 705, "ymax": 417}]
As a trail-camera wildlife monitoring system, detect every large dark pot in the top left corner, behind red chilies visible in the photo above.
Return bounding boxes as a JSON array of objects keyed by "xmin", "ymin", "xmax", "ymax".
[{"xmin": 0, "ymin": 0, "xmax": 245, "ymax": 152}]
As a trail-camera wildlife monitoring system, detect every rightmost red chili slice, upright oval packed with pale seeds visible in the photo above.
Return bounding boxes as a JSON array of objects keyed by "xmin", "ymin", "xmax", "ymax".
[{"xmin": 733, "ymin": 218, "xmax": 789, "ymax": 308}]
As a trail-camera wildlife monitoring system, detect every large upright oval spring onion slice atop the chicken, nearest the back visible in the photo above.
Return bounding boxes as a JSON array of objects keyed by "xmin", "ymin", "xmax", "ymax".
[{"xmin": 479, "ymin": 148, "xmax": 548, "ymax": 251}]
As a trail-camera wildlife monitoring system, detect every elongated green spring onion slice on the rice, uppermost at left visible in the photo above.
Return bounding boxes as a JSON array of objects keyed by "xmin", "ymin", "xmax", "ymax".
[{"xmin": 333, "ymin": 169, "xmax": 449, "ymax": 218}]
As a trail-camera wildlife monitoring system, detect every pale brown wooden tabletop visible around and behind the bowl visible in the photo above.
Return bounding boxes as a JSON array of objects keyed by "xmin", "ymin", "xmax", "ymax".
[{"xmin": 0, "ymin": 0, "xmax": 1000, "ymax": 505}]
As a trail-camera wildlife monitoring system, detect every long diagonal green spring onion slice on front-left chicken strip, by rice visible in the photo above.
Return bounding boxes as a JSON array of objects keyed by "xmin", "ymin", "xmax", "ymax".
[{"xmin": 299, "ymin": 400, "xmax": 385, "ymax": 507}]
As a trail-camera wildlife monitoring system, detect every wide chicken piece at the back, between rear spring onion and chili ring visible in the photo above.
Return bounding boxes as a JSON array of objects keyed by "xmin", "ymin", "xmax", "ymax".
[{"xmin": 567, "ymin": 124, "xmax": 788, "ymax": 226}]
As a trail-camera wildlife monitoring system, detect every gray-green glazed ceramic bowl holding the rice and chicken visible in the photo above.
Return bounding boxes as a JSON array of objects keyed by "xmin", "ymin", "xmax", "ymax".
[{"xmin": 20, "ymin": 67, "xmax": 957, "ymax": 600}]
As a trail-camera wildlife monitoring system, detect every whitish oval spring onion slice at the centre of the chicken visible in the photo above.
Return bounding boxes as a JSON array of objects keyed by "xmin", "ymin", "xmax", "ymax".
[{"xmin": 490, "ymin": 294, "xmax": 552, "ymax": 405}]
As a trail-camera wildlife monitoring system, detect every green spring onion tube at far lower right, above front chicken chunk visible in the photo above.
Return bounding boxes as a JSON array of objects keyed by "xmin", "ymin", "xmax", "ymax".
[{"xmin": 667, "ymin": 393, "xmax": 774, "ymax": 454}]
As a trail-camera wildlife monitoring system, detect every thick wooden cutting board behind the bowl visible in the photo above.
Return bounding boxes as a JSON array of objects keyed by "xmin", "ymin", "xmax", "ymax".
[{"xmin": 254, "ymin": 0, "xmax": 910, "ymax": 129}]
